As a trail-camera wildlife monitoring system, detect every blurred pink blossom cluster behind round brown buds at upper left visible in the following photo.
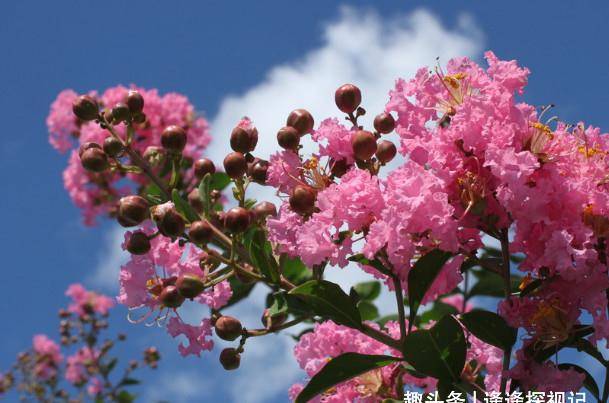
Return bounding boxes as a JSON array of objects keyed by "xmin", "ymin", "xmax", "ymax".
[{"xmin": 47, "ymin": 86, "xmax": 211, "ymax": 225}]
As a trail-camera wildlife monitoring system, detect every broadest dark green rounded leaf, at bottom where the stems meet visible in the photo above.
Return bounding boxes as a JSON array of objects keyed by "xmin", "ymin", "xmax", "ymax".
[{"xmin": 404, "ymin": 316, "xmax": 466, "ymax": 380}]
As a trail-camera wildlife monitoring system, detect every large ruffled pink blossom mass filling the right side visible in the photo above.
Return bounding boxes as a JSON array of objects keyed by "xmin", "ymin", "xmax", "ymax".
[{"xmin": 268, "ymin": 52, "xmax": 609, "ymax": 398}]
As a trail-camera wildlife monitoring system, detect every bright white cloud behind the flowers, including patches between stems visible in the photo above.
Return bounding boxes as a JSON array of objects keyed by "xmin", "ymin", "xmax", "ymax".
[{"xmin": 93, "ymin": 7, "xmax": 483, "ymax": 403}]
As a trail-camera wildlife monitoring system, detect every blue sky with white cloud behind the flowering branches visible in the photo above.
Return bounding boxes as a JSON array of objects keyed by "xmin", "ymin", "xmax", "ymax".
[{"xmin": 0, "ymin": 0, "xmax": 609, "ymax": 402}]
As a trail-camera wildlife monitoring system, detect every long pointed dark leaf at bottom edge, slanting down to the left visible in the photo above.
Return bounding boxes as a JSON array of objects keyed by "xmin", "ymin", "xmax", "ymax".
[{"xmin": 295, "ymin": 353, "xmax": 399, "ymax": 403}]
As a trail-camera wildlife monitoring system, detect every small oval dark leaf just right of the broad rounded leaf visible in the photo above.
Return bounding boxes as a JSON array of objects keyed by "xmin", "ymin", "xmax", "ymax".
[{"xmin": 461, "ymin": 310, "xmax": 517, "ymax": 351}]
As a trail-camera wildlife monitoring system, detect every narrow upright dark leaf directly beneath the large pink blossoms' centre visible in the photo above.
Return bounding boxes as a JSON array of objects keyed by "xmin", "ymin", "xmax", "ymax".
[{"xmin": 408, "ymin": 249, "xmax": 452, "ymax": 328}]
